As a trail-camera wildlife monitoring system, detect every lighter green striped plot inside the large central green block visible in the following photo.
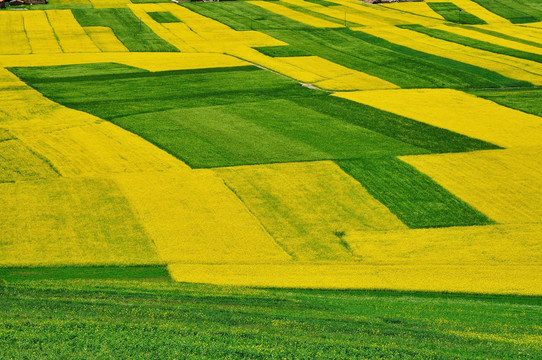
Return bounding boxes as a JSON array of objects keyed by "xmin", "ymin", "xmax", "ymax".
[{"xmin": 112, "ymin": 100, "xmax": 426, "ymax": 168}]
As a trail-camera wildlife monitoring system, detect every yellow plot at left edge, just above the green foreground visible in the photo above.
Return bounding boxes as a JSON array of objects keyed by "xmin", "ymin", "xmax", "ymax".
[{"xmin": 0, "ymin": 179, "xmax": 161, "ymax": 266}]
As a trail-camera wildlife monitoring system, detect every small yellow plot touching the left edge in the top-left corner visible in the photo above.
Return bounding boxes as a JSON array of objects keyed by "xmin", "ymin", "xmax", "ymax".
[{"xmin": 0, "ymin": 11, "xmax": 31, "ymax": 55}]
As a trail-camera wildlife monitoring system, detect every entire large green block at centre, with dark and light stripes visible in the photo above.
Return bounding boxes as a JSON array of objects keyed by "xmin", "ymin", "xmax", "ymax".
[{"xmin": 10, "ymin": 64, "xmax": 506, "ymax": 168}]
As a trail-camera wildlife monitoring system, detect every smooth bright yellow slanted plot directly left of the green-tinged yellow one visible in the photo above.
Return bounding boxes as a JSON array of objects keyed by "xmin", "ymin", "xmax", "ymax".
[{"xmin": 115, "ymin": 170, "xmax": 289, "ymax": 264}]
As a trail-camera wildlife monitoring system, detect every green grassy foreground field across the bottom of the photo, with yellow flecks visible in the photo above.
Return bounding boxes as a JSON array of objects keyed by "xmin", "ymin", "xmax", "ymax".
[{"xmin": 0, "ymin": 268, "xmax": 542, "ymax": 359}]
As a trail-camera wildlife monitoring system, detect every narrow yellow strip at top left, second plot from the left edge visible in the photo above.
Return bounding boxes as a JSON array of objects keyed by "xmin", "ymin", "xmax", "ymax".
[{"xmin": 23, "ymin": 11, "xmax": 62, "ymax": 54}]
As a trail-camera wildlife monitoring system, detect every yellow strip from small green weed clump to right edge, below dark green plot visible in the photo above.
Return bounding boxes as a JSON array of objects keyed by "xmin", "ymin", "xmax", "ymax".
[{"xmin": 344, "ymin": 224, "xmax": 542, "ymax": 266}]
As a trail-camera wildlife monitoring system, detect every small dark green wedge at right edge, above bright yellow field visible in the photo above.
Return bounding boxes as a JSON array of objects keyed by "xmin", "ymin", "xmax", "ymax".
[{"xmin": 469, "ymin": 88, "xmax": 542, "ymax": 117}]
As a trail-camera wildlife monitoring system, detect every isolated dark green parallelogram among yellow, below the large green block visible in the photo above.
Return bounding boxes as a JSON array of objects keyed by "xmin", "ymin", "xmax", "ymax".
[{"xmin": 337, "ymin": 157, "xmax": 494, "ymax": 228}]
